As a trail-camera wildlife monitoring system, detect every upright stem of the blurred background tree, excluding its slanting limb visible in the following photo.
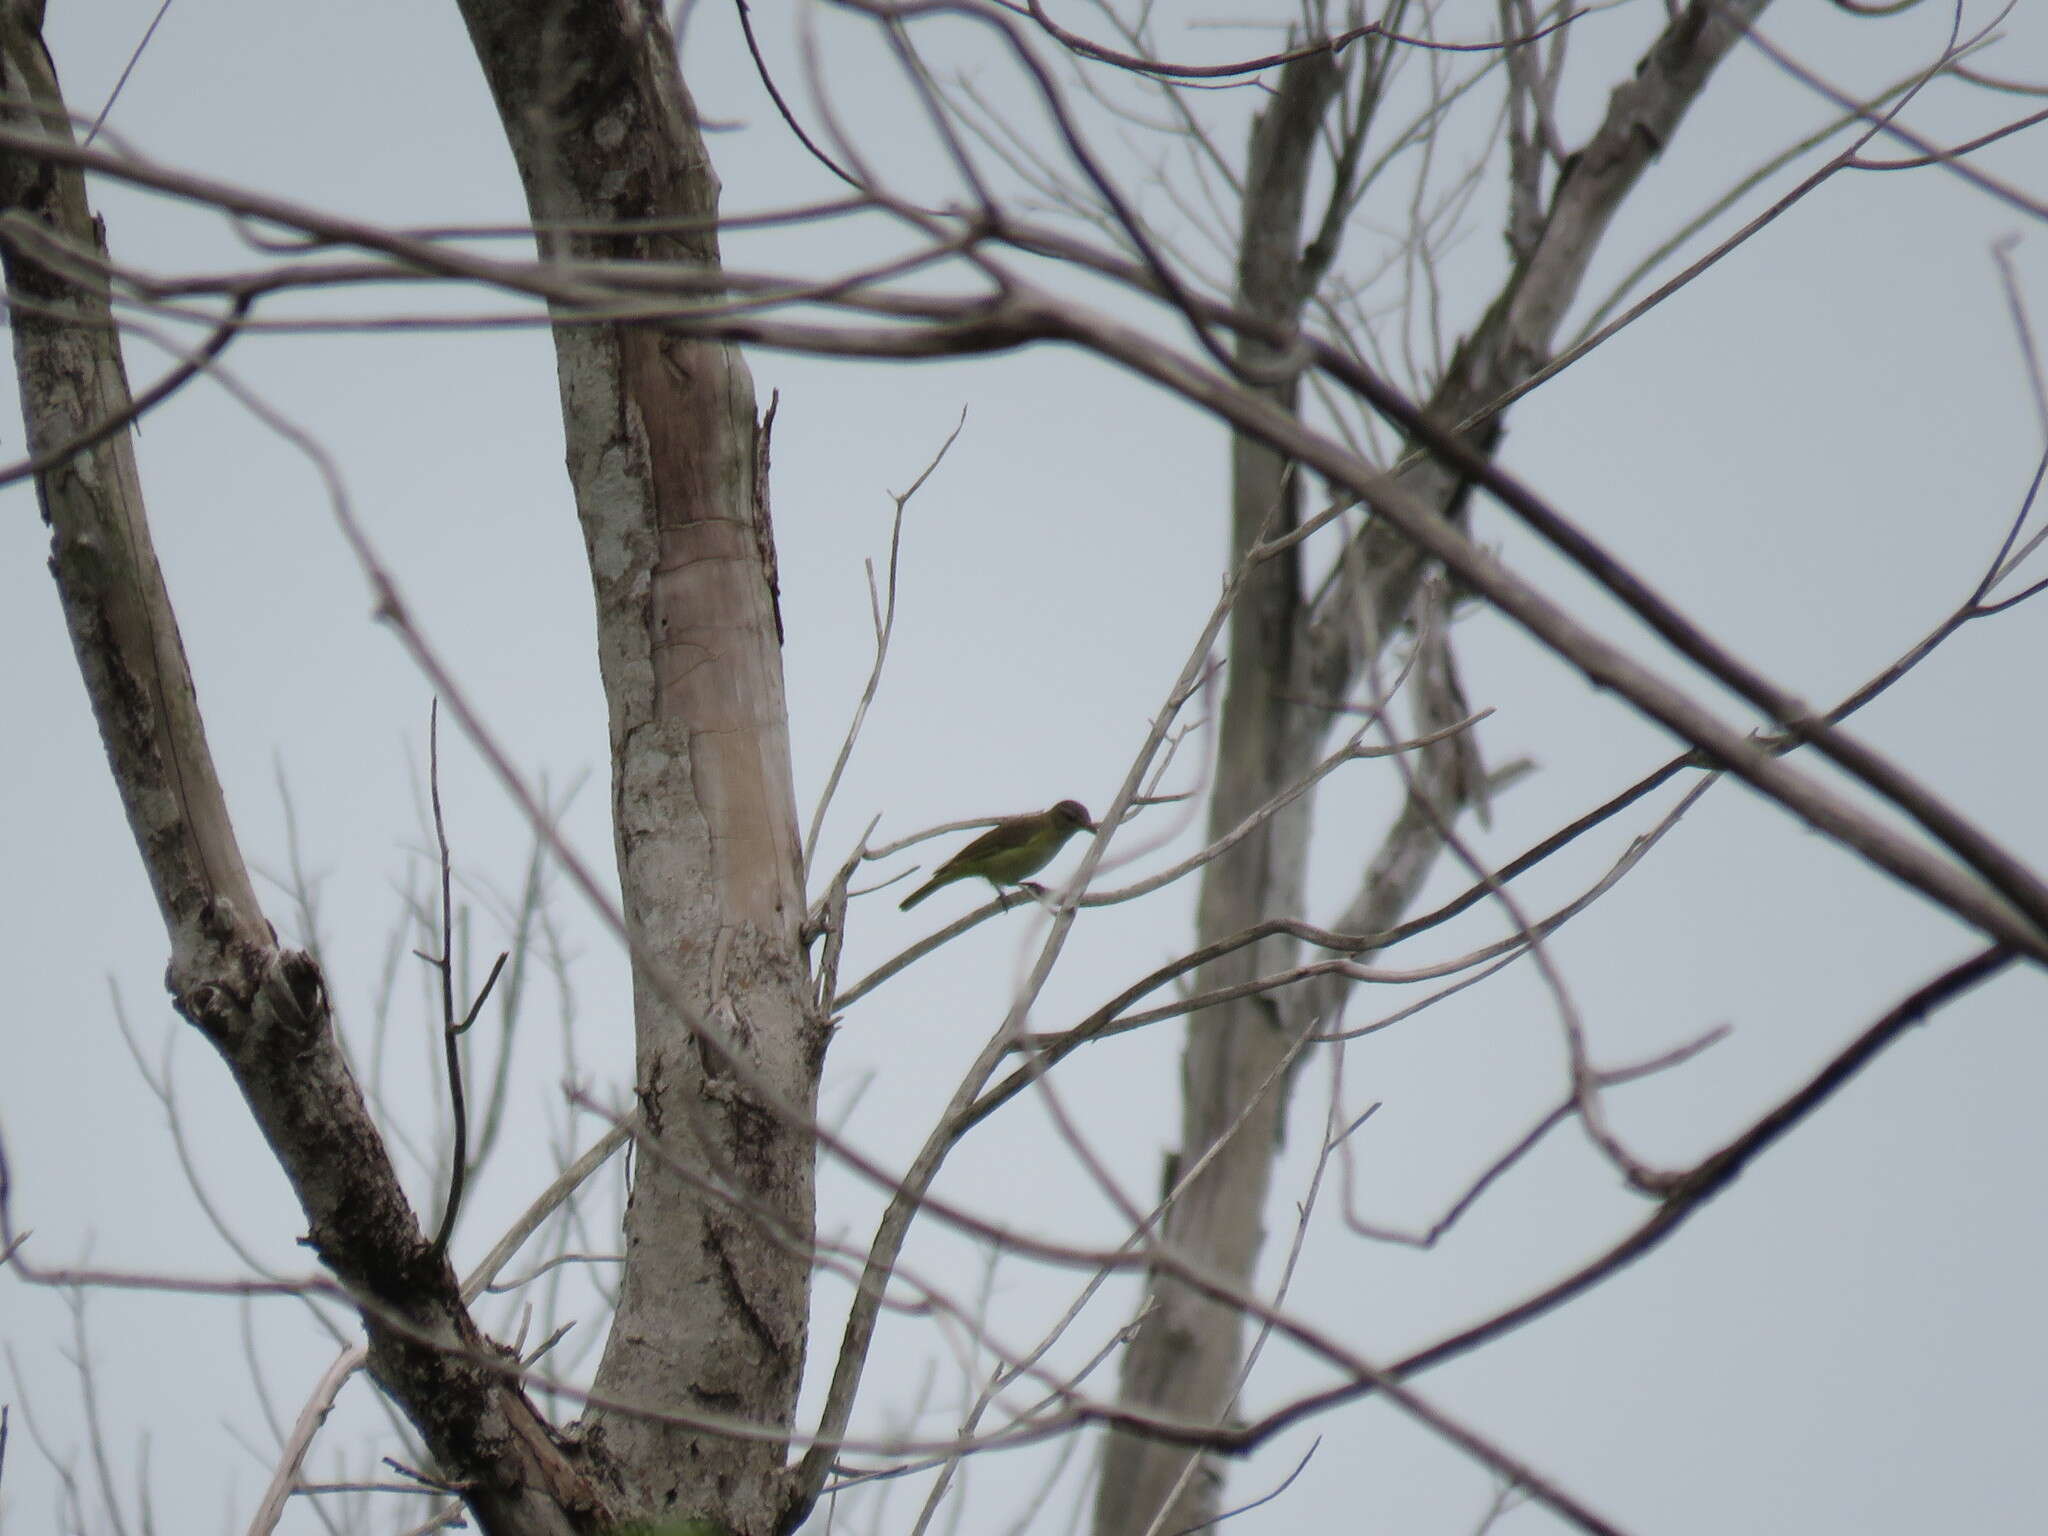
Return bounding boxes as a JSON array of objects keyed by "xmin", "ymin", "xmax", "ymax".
[{"xmin": 1096, "ymin": 53, "xmax": 1341, "ymax": 1536}]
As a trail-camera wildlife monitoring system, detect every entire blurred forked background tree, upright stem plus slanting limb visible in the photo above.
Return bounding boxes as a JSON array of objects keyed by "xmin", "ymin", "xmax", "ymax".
[{"xmin": 1094, "ymin": 0, "xmax": 1765, "ymax": 1536}]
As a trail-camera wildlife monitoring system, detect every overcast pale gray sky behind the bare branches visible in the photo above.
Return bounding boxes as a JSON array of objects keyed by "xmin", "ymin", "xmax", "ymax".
[{"xmin": 0, "ymin": 0, "xmax": 2048, "ymax": 1536}]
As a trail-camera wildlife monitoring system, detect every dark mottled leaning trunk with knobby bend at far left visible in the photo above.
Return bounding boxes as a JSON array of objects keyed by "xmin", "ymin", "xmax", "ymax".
[{"xmin": 0, "ymin": 0, "xmax": 602, "ymax": 1536}]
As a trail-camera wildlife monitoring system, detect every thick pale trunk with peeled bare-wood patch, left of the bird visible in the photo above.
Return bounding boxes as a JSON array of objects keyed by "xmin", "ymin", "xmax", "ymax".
[{"xmin": 463, "ymin": 0, "xmax": 825, "ymax": 1536}]
